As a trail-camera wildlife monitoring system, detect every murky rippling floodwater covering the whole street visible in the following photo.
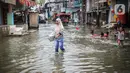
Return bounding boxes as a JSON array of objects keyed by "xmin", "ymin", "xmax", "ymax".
[{"xmin": 0, "ymin": 24, "xmax": 130, "ymax": 73}]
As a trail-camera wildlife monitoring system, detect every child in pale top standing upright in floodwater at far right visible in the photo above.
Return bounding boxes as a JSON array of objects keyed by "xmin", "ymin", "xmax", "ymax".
[{"xmin": 117, "ymin": 27, "xmax": 125, "ymax": 46}]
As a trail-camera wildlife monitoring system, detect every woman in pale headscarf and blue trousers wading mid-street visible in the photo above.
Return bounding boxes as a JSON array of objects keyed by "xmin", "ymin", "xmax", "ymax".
[{"xmin": 55, "ymin": 18, "xmax": 65, "ymax": 53}]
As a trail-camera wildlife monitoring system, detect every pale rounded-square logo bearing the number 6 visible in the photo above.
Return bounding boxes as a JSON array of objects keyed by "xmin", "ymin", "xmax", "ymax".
[{"xmin": 115, "ymin": 4, "xmax": 125, "ymax": 15}]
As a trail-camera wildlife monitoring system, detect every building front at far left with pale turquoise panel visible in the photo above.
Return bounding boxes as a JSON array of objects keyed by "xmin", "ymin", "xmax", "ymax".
[{"xmin": 0, "ymin": 0, "xmax": 16, "ymax": 25}]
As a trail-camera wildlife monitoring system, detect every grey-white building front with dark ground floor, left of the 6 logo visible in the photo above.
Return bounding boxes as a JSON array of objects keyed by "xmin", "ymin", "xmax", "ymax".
[{"xmin": 86, "ymin": 0, "xmax": 109, "ymax": 26}]
